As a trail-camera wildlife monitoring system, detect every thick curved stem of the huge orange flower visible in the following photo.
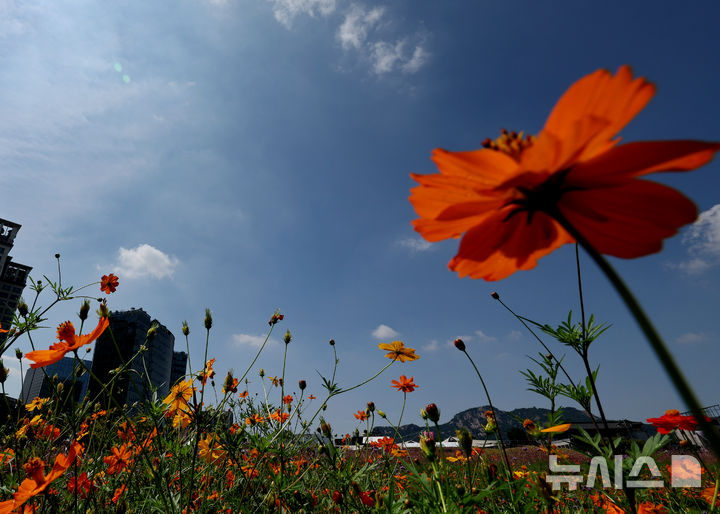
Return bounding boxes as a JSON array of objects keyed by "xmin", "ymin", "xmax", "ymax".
[{"xmin": 549, "ymin": 209, "xmax": 720, "ymax": 457}]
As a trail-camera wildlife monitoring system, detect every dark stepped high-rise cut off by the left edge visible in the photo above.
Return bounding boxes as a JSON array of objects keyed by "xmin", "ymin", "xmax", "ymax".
[{"xmin": 0, "ymin": 218, "xmax": 32, "ymax": 343}]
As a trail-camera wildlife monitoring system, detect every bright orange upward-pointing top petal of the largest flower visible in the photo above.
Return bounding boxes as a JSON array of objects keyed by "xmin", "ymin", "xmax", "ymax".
[{"xmin": 543, "ymin": 66, "xmax": 655, "ymax": 161}]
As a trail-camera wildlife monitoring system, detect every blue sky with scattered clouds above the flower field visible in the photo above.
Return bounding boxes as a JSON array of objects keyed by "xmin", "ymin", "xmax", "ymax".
[{"xmin": 0, "ymin": 0, "xmax": 720, "ymax": 433}]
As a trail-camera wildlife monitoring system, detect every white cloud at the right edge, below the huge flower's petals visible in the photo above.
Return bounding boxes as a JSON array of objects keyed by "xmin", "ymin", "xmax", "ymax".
[{"xmin": 669, "ymin": 204, "xmax": 720, "ymax": 275}]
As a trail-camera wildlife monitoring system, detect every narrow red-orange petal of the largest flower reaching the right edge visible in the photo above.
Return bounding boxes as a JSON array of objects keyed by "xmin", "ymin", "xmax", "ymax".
[{"xmin": 568, "ymin": 140, "xmax": 720, "ymax": 187}]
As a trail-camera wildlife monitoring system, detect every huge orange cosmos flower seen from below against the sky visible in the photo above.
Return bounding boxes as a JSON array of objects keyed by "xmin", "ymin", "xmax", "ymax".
[{"xmin": 410, "ymin": 66, "xmax": 720, "ymax": 280}]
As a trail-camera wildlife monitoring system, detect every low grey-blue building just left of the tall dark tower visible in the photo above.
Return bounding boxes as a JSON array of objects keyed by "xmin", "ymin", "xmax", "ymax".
[{"xmin": 20, "ymin": 357, "xmax": 92, "ymax": 404}]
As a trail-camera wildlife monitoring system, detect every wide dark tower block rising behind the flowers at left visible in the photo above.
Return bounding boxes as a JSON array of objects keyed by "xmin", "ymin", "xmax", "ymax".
[{"xmin": 88, "ymin": 309, "xmax": 175, "ymax": 407}]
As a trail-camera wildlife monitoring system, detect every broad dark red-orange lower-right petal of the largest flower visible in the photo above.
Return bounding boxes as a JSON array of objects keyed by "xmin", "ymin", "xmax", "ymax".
[{"xmin": 558, "ymin": 179, "xmax": 697, "ymax": 259}]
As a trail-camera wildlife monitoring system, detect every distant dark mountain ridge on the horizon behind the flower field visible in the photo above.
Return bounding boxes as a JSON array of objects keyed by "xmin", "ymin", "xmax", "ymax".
[{"xmin": 371, "ymin": 405, "xmax": 590, "ymax": 440}]
